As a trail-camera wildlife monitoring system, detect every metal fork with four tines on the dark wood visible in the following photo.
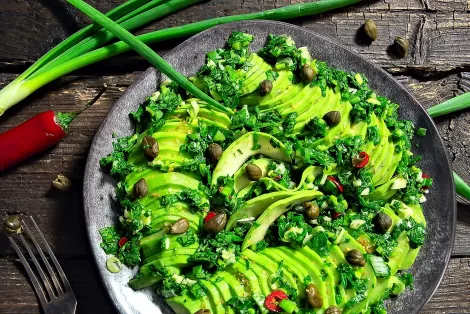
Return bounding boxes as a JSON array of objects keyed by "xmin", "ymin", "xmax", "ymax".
[{"xmin": 7, "ymin": 217, "xmax": 77, "ymax": 314}]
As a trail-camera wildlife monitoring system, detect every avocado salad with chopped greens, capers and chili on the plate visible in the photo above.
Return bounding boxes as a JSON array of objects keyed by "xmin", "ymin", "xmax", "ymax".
[{"xmin": 100, "ymin": 32, "xmax": 432, "ymax": 314}]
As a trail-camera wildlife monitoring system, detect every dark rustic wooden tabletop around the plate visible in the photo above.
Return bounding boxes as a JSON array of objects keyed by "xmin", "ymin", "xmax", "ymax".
[{"xmin": 0, "ymin": 0, "xmax": 470, "ymax": 314}]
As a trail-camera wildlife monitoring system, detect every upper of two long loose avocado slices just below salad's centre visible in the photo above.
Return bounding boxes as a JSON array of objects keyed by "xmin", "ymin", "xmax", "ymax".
[{"xmin": 225, "ymin": 191, "xmax": 295, "ymax": 230}]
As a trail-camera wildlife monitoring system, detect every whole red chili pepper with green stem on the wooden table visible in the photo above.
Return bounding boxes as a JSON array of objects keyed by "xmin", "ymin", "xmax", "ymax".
[{"xmin": 0, "ymin": 87, "xmax": 106, "ymax": 171}]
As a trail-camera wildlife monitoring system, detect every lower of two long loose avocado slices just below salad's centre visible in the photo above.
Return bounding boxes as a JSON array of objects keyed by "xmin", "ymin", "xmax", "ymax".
[{"xmin": 242, "ymin": 190, "xmax": 322, "ymax": 250}]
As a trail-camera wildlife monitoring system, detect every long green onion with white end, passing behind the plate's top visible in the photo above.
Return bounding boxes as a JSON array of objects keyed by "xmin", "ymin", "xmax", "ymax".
[{"xmin": 0, "ymin": 0, "xmax": 361, "ymax": 115}]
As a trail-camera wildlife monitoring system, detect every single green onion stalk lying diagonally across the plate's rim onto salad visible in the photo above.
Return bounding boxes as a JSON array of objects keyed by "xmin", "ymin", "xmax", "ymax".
[{"xmin": 67, "ymin": 0, "xmax": 231, "ymax": 112}]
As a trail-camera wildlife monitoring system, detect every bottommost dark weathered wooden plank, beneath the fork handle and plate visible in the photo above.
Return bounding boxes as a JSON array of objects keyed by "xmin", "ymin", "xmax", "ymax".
[{"xmin": 0, "ymin": 258, "xmax": 470, "ymax": 314}]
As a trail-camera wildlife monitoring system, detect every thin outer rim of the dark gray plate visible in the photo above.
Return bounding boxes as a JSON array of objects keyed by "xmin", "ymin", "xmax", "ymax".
[{"xmin": 83, "ymin": 19, "xmax": 457, "ymax": 313}]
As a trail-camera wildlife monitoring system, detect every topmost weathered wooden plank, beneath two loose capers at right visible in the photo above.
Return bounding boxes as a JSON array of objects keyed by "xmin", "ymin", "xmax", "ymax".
[{"xmin": 0, "ymin": 0, "xmax": 470, "ymax": 73}]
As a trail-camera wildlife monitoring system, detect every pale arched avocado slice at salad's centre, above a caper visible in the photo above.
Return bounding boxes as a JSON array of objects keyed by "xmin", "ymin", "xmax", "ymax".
[{"xmin": 212, "ymin": 132, "xmax": 291, "ymax": 185}]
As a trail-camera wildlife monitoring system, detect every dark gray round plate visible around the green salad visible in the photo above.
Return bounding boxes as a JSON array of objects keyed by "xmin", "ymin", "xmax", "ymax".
[{"xmin": 84, "ymin": 21, "xmax": 456, "ymax": 314}]
